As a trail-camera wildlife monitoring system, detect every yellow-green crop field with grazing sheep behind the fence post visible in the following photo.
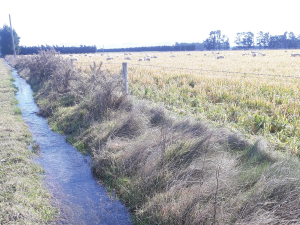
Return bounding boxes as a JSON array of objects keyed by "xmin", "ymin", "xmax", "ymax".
[{"xmin": 67, "ymin": 50, "xmax": 300, "ymax": 155}]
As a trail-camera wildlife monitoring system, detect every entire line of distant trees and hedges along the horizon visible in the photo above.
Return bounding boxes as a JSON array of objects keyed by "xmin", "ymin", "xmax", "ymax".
[{"xmin": 0, "ymin": 25, "xmax": 300, "ymax": 56}]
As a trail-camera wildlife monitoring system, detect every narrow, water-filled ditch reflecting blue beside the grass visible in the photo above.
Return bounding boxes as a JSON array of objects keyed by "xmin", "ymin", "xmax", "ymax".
[{"xmin": 13, "ymin": 67, "xmax": 131, "ymax": 225}]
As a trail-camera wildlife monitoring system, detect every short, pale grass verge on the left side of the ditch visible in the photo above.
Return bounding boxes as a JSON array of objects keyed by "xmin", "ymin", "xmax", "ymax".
[{"xmin": 0, "ymin": 59, "xmax": 54, "ymax": 224}]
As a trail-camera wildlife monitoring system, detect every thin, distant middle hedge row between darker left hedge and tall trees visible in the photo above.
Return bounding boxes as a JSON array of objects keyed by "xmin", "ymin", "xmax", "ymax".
[{"xmin": 97, "ymin": 44, "xmax": 196, "ymax": 52}]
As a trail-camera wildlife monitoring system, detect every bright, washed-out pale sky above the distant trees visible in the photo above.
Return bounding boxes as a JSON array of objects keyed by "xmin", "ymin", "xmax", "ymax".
[{"xmin": 0, "ymin": 0, "xmax": 300, "ymax": 47}]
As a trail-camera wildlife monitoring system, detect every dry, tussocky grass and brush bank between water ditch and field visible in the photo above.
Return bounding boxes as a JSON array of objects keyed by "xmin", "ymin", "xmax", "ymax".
[{"xmin": 5, "ymin": 51, "xmax": 300, "ymax": 224}]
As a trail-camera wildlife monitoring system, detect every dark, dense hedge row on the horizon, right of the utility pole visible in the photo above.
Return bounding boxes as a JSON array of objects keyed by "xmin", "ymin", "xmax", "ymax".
[{"xmin": 20, "ymin": 45, "xmax": 97, "ymax": 55}]
